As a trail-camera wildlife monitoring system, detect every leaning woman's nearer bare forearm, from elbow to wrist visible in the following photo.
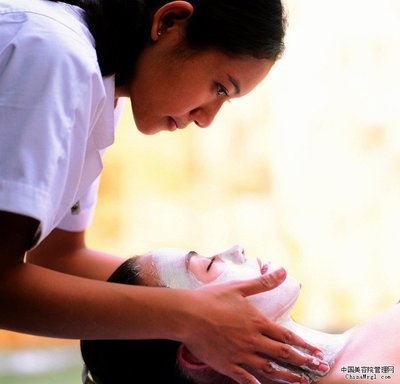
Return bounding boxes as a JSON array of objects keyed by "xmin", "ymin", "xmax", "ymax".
[{"xmin": 0, "ymin": 264, "xmax": 189, "ymax": 339}]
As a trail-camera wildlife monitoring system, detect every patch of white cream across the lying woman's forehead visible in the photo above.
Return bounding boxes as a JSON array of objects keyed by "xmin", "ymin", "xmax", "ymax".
[{"xmin": 151, "ymin": 248, "xmax": 204, "ymax": 289}]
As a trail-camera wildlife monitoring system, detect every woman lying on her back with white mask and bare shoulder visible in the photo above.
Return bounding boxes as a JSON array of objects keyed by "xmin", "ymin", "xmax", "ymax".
[{"xmin": 81, "ymin": 246, "xmax": 400, "ymax": 384}]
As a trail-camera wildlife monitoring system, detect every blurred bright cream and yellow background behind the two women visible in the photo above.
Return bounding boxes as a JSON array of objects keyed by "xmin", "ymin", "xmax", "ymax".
[{"xmin": 0, "ymin": 0, "xmax": 400, "ymax": 384}]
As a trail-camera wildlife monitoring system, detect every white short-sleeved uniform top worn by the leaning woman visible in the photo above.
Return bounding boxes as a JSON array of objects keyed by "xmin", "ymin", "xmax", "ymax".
[{"xmin": 0, "ymin": 0, "xmax": 115, "ymax": 244}]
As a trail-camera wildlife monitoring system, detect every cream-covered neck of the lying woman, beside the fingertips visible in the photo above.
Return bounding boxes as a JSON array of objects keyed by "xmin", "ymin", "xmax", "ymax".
[{"xmin": 278, "ymin": 314, "xmax": 351, "ymax": 381}]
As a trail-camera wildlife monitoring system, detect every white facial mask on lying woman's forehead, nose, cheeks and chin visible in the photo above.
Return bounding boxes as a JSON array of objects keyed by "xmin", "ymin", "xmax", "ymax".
[{"xmin": 151, "ymin": 247, "xmax": 299, "ymax": 320}]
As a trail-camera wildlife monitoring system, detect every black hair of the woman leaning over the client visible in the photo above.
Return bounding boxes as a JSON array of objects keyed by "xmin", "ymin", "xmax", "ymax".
[{"xmin": 49, "ymin": 0, "xmax": 286, "ymax": 85}]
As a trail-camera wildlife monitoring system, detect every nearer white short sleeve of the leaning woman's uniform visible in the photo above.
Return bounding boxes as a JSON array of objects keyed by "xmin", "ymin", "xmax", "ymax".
[{"xmin": 0, "ymin": 5, "xmax": 104, "ymax": 240}]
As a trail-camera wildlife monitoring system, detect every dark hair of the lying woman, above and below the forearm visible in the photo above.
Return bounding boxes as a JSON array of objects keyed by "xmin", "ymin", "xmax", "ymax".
[{"xmin": 80, "ymin": 258, "xmax": 193, "ymax": 384}]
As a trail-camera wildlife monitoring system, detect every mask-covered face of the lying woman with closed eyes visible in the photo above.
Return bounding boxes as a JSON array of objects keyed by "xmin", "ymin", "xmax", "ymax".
[{"xmin": 141, "ymin": 246, "xmax": 300, "ymax": 320}]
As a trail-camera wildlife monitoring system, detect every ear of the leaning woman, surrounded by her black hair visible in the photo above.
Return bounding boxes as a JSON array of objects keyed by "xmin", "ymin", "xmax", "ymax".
[{"xmin": 150, "ymin": 1, "xmax": 193, "ymax": 41}]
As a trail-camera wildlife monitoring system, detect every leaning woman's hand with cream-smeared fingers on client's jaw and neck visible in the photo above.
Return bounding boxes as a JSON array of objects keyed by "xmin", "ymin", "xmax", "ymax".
[{"xmin": 182, "ymin": 269, "xmax": 326, "ymax": 384}]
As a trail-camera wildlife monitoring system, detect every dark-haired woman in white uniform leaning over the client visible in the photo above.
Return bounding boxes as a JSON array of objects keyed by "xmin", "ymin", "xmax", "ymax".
[{"xmin": 0, "ymin": 0, "xmax": 328, "ymax": 384}]
